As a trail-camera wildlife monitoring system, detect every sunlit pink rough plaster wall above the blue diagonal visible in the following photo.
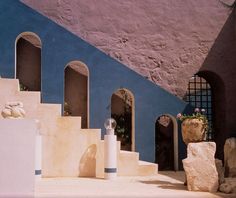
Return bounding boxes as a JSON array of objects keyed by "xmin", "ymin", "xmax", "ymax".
[{"xmin": 22, "ymin": 0, "xmax": 233, "ymax": 97}]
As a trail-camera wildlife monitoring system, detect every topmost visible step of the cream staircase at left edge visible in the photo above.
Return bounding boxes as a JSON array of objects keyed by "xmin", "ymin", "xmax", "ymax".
[{"xmin": 0, "ymin": 78, "xmax": 20, "ymax": 94}]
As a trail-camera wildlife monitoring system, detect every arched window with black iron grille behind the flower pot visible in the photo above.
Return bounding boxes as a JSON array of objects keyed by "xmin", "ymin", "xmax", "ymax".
[{"xmin": 184, "ymin": 75, "xmax": 214, "ymax": 140}]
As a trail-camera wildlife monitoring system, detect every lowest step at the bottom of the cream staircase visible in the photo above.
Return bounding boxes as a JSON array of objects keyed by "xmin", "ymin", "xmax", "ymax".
[{"xmin": 138, "ymin": 161, "xmax": 158, "ymax": 176}]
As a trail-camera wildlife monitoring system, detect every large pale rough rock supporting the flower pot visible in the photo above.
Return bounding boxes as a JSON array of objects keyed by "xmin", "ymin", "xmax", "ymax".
[{"xmin": 183, "ymin": 142, "xmax": 219, "ymax": 192}]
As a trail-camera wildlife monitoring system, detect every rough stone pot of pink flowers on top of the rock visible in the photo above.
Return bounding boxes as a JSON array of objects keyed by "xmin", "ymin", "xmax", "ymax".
[{"xmin": 177, "ymin": 108, "xmax": 208, "ymax": 145}]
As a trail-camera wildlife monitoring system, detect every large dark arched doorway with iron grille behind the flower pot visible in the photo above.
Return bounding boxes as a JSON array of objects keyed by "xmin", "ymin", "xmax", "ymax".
[{"xmin": 184, "ymin": 70, "xmax": 228, "ymax": 160}]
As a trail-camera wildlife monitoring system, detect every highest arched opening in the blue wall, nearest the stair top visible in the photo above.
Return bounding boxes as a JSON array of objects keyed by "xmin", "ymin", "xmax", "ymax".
[{"xmin": 15, "ymin": 32, "xmax": 42, "ymax": 91}]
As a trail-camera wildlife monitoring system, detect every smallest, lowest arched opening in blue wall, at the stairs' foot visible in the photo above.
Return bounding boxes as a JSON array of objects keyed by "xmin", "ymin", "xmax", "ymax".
[{"xmin": 155, "ymin": 114, "xmax": 179, "ymax": 171}]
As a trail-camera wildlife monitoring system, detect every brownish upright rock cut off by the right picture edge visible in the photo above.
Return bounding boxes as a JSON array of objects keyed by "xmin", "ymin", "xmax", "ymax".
[{"xmin": 224, "ymin": 137, "xmax": 236, "ymax": 177}]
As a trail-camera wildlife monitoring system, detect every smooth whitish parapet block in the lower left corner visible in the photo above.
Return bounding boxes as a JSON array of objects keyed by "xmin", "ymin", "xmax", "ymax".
[{"xmin": 0, "ymin": 119, "xmax": 38, "ymax": 198}]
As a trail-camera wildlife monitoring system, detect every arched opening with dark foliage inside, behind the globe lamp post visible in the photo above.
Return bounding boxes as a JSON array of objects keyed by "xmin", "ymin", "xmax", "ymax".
[{"xmin": 111, "ymin": 88, "xmax": 135, "ymax": 151}]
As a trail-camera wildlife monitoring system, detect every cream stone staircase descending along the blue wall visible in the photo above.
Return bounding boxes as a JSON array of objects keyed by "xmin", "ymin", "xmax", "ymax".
[{"xmin": 0, "ymin": 78, "xmax": 157, "ymax": 177}]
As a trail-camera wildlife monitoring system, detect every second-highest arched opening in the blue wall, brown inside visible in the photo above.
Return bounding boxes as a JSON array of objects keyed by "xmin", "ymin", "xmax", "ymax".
[{"xmin": 64, "ymin": 61, "xmax": 89, "ymax": 128}]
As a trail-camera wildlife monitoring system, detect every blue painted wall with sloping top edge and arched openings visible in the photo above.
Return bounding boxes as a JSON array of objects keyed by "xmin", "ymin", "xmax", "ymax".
[{"xmin": 0, "ymin": 0, "xmax": 190, "ymax": 162}]
